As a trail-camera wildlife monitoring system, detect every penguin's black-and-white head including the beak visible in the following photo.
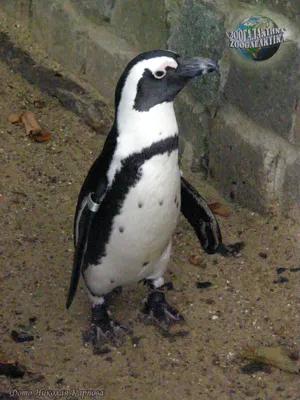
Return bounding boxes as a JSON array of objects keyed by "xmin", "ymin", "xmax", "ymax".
[{"xmin": 115, "ymin": 50, "xmax": 218, "ymax": 112}]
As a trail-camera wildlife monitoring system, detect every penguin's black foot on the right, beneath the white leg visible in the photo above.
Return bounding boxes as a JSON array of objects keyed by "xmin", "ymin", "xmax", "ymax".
[{"xmin": 139, "ymin": 289, "xmax": 184, "ymax": 335}]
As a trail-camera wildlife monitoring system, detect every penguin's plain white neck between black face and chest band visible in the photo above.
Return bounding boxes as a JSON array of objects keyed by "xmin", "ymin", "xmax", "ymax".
[{"xmin": 116, "ymin": 102, "xmax": 178, "ymax": 159}]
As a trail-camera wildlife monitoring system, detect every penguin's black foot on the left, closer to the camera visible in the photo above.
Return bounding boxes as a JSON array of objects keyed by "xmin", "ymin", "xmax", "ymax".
[{"xmin": 84, "ymin": 304, "xmax": 132, "ymax": 354}]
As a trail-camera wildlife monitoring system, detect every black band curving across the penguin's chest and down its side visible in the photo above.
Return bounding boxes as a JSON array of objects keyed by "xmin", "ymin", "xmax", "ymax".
[{"xmin": 84, "ymin": 135, "xmax": 178, "ymax": 268}]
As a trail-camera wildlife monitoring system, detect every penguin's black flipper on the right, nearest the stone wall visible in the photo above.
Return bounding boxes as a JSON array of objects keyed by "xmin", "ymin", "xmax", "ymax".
[{"xmin": 181, "ymin": 176, "xmax": 222, "ymax": 254}]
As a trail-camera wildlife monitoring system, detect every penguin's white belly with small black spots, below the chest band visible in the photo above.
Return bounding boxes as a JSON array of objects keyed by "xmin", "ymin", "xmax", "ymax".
[{"xmin": 85, "ymin": 150, "xmax": 181, "ymax": 295}]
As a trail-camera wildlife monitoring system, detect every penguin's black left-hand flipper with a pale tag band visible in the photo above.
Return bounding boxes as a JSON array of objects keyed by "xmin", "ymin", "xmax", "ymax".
[{"xmin": 66, "ymin": 184, "xmax": 106, "ymax": 309}]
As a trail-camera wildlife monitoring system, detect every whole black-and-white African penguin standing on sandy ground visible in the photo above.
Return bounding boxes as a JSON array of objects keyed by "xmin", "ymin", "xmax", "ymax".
[{"xmin": 67, "ymin": 50, "xmax": 221, "ymax": 345}]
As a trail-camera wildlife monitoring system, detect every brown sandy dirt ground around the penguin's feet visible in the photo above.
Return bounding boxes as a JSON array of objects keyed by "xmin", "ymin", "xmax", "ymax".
[{"xmin": 0, "ymin": 13, "xmax": 300, "ymax": 400}]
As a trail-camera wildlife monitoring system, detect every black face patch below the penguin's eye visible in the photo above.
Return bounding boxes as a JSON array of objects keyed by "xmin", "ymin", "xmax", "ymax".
[{"xmin": 133, "ymin": 67, "xmax": 188, "ymax": 112}]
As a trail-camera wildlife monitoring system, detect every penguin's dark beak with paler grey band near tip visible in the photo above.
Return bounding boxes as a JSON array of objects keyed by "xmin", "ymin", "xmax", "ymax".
[{"xmin": 176, "ymin": 57, "xmax": 219, "ymax": 78}]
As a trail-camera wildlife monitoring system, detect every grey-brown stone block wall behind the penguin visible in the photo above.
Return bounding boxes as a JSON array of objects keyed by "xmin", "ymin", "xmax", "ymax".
[{"xmin": 0, "ymin": 0, "xmax": 300, "ymax": 218}]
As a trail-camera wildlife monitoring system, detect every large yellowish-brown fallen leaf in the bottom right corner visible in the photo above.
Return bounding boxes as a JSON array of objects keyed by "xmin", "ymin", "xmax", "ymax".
[{"xmin": 241, "ymin": 347, "xmax": 299, "ymax": 374}]
